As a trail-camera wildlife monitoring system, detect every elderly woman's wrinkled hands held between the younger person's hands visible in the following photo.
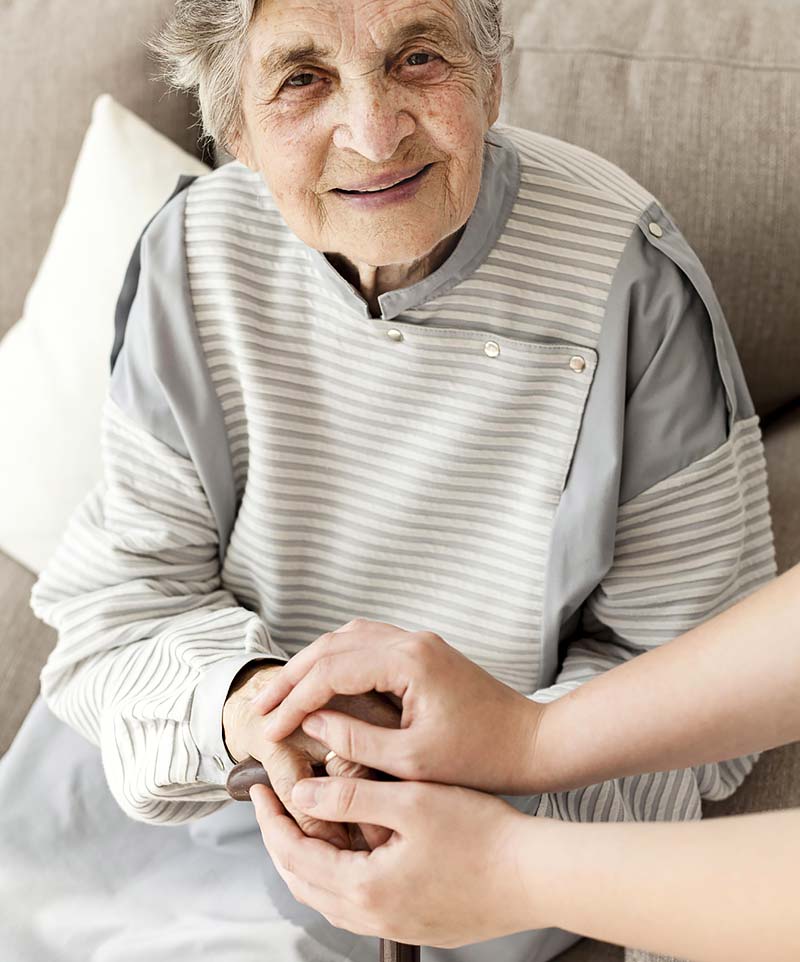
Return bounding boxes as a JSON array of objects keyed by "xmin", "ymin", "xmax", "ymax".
[{"xmin": 223, "ymin": 665, "xmax": 400, "ymax": 849}]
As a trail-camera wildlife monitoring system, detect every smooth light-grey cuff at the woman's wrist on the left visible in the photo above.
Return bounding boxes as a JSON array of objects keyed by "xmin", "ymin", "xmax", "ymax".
[{"xmin": 189, "ymin": 654, "xmax": 288, "ymax": 785}]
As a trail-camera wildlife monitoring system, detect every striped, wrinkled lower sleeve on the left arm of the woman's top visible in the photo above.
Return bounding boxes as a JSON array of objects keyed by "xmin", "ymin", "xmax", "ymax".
[{"xmin": 31, "ymin": 397, "xmax": 288, "ymax": 823}]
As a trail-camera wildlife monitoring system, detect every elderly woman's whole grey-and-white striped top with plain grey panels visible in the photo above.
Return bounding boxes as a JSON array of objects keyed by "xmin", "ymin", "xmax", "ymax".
[{"xmin": 31, "ymin": 125, "xmax": 775, "ymax": 823}]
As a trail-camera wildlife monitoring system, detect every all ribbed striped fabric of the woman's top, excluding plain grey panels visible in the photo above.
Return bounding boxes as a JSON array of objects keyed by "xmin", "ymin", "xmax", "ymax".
[{"xmin": 31, "ymin": 124, "xmax": 772, "ymax": 822}]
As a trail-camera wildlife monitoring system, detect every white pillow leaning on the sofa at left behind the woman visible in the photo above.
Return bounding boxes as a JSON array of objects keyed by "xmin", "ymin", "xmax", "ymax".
[{"xmin": 0, "ymin": 94, "xmax": 210, "ymax": 574}]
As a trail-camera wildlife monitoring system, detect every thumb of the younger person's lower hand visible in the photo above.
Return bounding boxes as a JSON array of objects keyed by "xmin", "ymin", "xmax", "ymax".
[{"xmin": 292, "ymin": 776, "xmax": 418, "ymax": 832}]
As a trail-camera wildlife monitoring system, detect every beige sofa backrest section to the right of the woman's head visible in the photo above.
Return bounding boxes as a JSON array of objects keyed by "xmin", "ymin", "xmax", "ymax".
[{"xmin": 501, "ymin": 0, "xmax": 800, "ymax": 415}]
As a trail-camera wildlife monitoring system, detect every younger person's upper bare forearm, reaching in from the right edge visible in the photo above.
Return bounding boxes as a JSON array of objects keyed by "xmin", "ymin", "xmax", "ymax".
[{"xmin": 531, "ymin": 566, "xmax": 800, "ymax": 791}]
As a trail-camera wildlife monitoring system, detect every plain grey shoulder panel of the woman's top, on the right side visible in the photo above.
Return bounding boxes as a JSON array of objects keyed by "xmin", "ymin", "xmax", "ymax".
[{"xmin": 542, "ymin": 216, "xmax": 736, "ymax": 678}]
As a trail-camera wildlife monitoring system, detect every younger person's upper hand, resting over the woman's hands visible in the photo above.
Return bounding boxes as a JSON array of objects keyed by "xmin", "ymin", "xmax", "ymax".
[{"xmin": 254, "ymin": 618, "xmax": 545, "ymax": 795}]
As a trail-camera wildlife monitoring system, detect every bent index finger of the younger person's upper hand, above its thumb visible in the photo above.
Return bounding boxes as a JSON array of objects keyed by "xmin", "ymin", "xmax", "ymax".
[{"xmin": 258, "ymin": 648, "xmax": 408, "ymax": 748}]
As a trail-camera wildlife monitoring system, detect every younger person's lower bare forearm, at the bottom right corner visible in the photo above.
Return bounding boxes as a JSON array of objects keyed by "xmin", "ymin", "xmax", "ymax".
[{"xmin": 517, "ymin": 811, "xmax": 800, "ymax": 962}]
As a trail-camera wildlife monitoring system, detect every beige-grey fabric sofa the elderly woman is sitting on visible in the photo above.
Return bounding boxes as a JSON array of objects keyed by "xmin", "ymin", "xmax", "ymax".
[{"xmin": 0, "ymin": 0, "xmax": 800, "ymax": 962}]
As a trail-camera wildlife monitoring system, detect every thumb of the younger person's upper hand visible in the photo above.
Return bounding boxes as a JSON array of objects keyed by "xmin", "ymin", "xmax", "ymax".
[{"xmin": 302, "ymin": 711, "xmax": 409, "ymax": 778}]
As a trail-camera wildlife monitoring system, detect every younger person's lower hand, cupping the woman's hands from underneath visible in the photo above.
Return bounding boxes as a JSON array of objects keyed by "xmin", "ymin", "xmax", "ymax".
[{"xmin": 250, "ymin": 778, "xmax": 544, "ymax": 948}]
